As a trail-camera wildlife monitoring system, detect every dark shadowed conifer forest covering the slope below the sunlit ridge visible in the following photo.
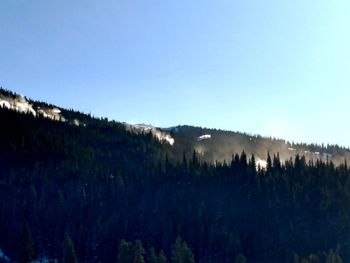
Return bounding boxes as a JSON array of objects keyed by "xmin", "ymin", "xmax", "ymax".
[{"xmin": 0, "ymin": 99, "xmax": 350, "ymax": 263}]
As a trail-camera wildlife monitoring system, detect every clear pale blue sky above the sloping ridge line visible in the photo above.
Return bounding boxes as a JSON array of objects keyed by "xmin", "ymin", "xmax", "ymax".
[{"xmin": 0, "ymin": 0, "xmax": 350, "ymax": 146}]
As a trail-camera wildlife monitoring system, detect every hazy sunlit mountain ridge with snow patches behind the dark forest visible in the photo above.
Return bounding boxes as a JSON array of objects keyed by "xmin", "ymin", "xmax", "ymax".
[{"xmin": 0, "ymin": 88, "xmax": 350, "ymax": 167}]
